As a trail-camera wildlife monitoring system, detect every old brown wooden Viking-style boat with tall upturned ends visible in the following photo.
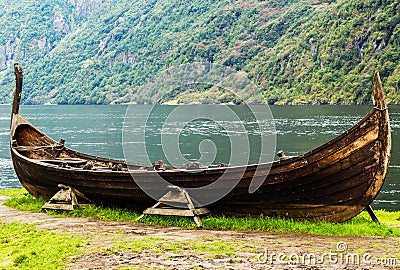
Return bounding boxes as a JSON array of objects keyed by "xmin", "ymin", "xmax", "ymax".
[{"xmin": 10, "ymin": 64, "xmax": 391, "ymax": 222}]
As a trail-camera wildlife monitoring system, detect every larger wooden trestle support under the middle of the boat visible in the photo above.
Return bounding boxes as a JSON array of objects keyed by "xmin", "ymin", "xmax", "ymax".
[{"xmin": 136, "ymin": 186, "xmax": 210, "ymax": 228}]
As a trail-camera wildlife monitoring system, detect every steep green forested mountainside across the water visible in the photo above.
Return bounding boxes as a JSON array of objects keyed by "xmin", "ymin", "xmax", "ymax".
[{"xmin": 0, "ymin": 0, "xmax": 400, "ymax": 104}]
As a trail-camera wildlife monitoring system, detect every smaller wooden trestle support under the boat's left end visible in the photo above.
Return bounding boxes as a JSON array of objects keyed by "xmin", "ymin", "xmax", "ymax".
[{"xmin": 42, "ymin": 184, "xmax": 93, "ymax": 210}]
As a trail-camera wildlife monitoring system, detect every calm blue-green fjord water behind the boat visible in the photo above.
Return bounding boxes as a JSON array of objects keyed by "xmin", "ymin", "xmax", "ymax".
[{"xmin": 0, "ymin": 105, "xmax": 400, "ymax": 210}]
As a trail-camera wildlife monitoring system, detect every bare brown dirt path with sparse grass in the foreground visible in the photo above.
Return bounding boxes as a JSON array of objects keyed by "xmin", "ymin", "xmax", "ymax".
[{"xmin": 0, "ymin": 196, "xmax": 400, "ymax": 269}]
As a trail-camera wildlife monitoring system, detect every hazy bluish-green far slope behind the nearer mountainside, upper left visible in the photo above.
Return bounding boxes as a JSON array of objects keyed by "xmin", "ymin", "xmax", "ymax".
[{"xmin": 0, "ymin": 0, "xmax": 106, "ymax": 102}]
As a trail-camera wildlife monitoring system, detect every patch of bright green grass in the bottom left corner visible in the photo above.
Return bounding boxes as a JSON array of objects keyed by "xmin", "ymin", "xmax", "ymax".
[{"xmin": 0, "ymin": 223, "xmax": 84, "ymax": 270}]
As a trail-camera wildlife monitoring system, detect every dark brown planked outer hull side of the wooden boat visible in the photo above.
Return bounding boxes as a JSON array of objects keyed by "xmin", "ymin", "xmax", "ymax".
[{"xmin": 12, "ymin": 105, "xmax": 390, "ymax": 222}]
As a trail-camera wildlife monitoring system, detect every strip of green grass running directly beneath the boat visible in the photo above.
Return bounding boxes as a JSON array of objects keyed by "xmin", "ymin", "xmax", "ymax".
[{"xmin": 2, "ymin": 191, "xmax": 400, "ymax": 237}]
